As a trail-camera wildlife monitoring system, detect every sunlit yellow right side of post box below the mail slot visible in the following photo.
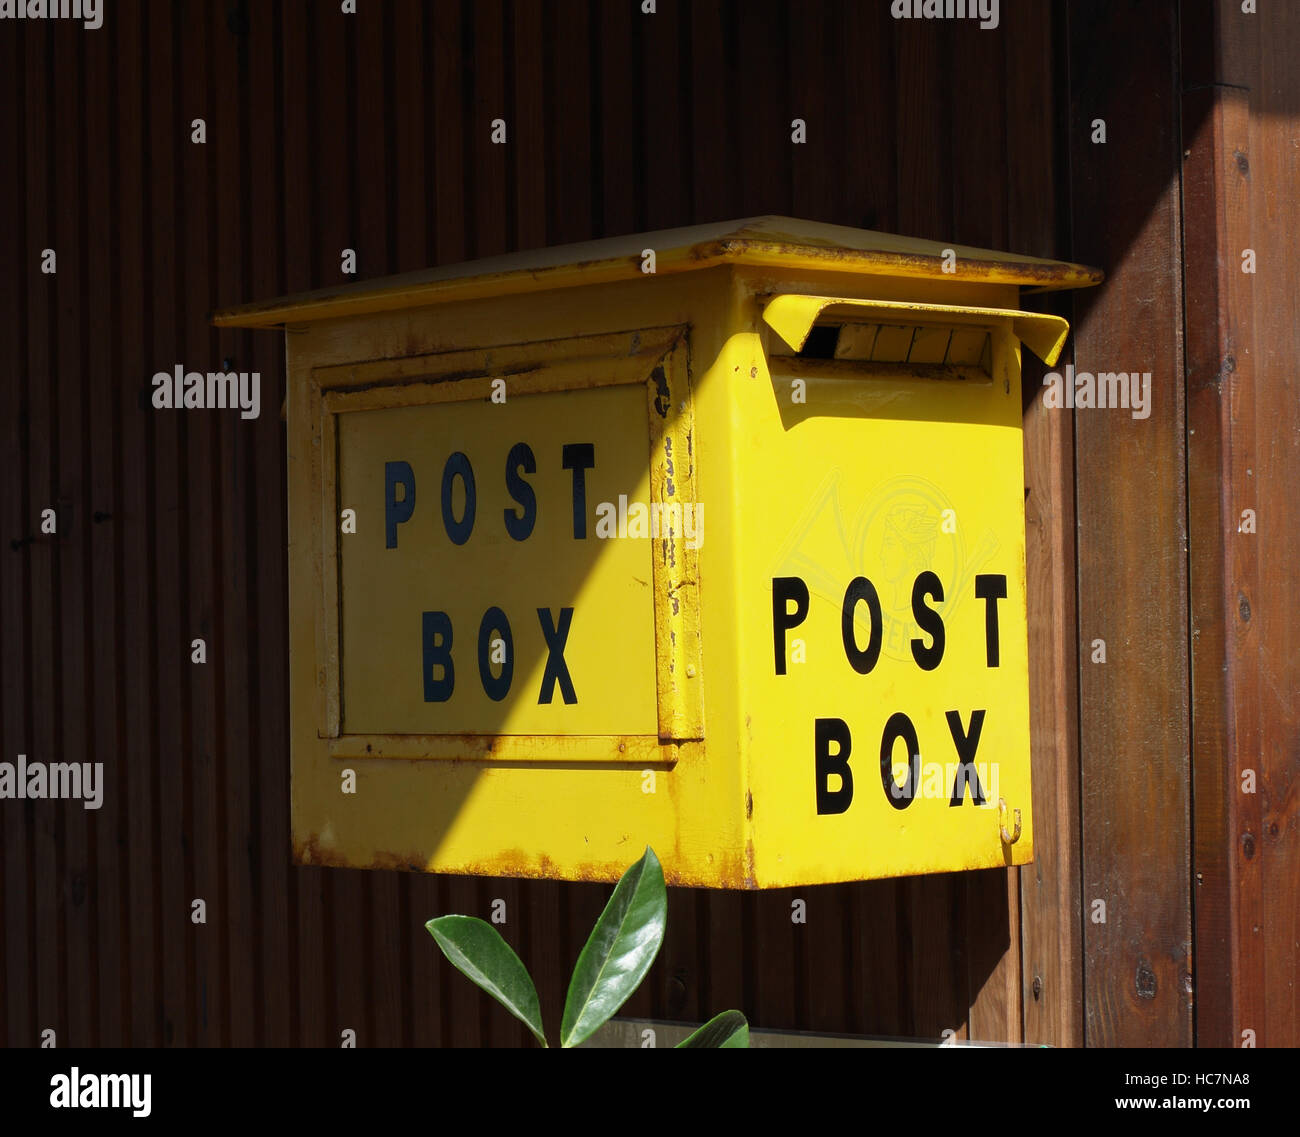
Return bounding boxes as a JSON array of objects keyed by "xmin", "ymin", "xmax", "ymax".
[{"xmin": 736, "ymin": 268, "xmax": 1032, "ymax": 888}]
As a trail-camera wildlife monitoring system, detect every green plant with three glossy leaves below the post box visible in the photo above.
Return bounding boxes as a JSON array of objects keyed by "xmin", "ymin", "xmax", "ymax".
[{"xmin": 424, "ymin": 846, "xmax": 749, "ymax": 1049}]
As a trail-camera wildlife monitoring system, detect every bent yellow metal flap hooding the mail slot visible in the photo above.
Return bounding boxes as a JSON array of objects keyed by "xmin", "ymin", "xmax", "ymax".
[{"xmin": 763, "ymin": 295, "xmax": 1070, "ymax": 366}]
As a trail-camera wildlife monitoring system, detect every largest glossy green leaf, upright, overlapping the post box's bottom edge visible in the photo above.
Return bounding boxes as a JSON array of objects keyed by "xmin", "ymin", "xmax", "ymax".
[{"xmin": 560, "ymin": 846, "xmax": 668, "ymax": 1046}]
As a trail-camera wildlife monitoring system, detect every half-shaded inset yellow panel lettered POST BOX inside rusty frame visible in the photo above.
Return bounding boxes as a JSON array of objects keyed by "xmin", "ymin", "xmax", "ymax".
[{"xmin": 338, "ymin": 385, "xmax": 658, "ymax": 735}]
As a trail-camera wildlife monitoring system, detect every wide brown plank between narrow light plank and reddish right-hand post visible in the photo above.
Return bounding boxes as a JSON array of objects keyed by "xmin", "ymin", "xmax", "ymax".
[{"xmin": 1067, "ymin": 4, "xmax": 1191, "ymax": 1046}]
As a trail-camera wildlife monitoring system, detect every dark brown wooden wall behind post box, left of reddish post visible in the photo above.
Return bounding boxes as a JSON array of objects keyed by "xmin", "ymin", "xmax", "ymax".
[{"xmin": 0, "ymin": 0, "xmax": 1296, "ymax": 1046}]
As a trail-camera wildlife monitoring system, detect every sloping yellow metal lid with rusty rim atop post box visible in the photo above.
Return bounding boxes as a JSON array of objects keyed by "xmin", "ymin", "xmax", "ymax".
[{"xmin": 212, "ymin": 216, "xmax": 1102, "ymax": 327}]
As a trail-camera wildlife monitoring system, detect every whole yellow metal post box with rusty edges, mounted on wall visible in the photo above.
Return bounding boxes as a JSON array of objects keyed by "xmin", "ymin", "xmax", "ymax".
[{"xmin": 215, "ymin": 217, "xmax": 1100, "ymax": 889}]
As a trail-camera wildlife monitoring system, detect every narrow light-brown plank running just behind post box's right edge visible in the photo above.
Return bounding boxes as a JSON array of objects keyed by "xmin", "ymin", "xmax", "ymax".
[{"xmin": 1005, "ymin": 5, "xmax": 1083, "ymax": 1046}]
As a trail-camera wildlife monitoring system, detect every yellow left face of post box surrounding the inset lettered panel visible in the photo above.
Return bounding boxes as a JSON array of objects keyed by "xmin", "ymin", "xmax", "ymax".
[{"xmin": 289, "ymin": 269, "xmax": 750, "ymax": 888}]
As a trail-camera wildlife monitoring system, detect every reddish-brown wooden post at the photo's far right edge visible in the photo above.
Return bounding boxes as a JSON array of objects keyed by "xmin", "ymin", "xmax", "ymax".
[{"xmin": 1182, "ymin": 0, "xmax": 1300, "ymax": 1047}]
